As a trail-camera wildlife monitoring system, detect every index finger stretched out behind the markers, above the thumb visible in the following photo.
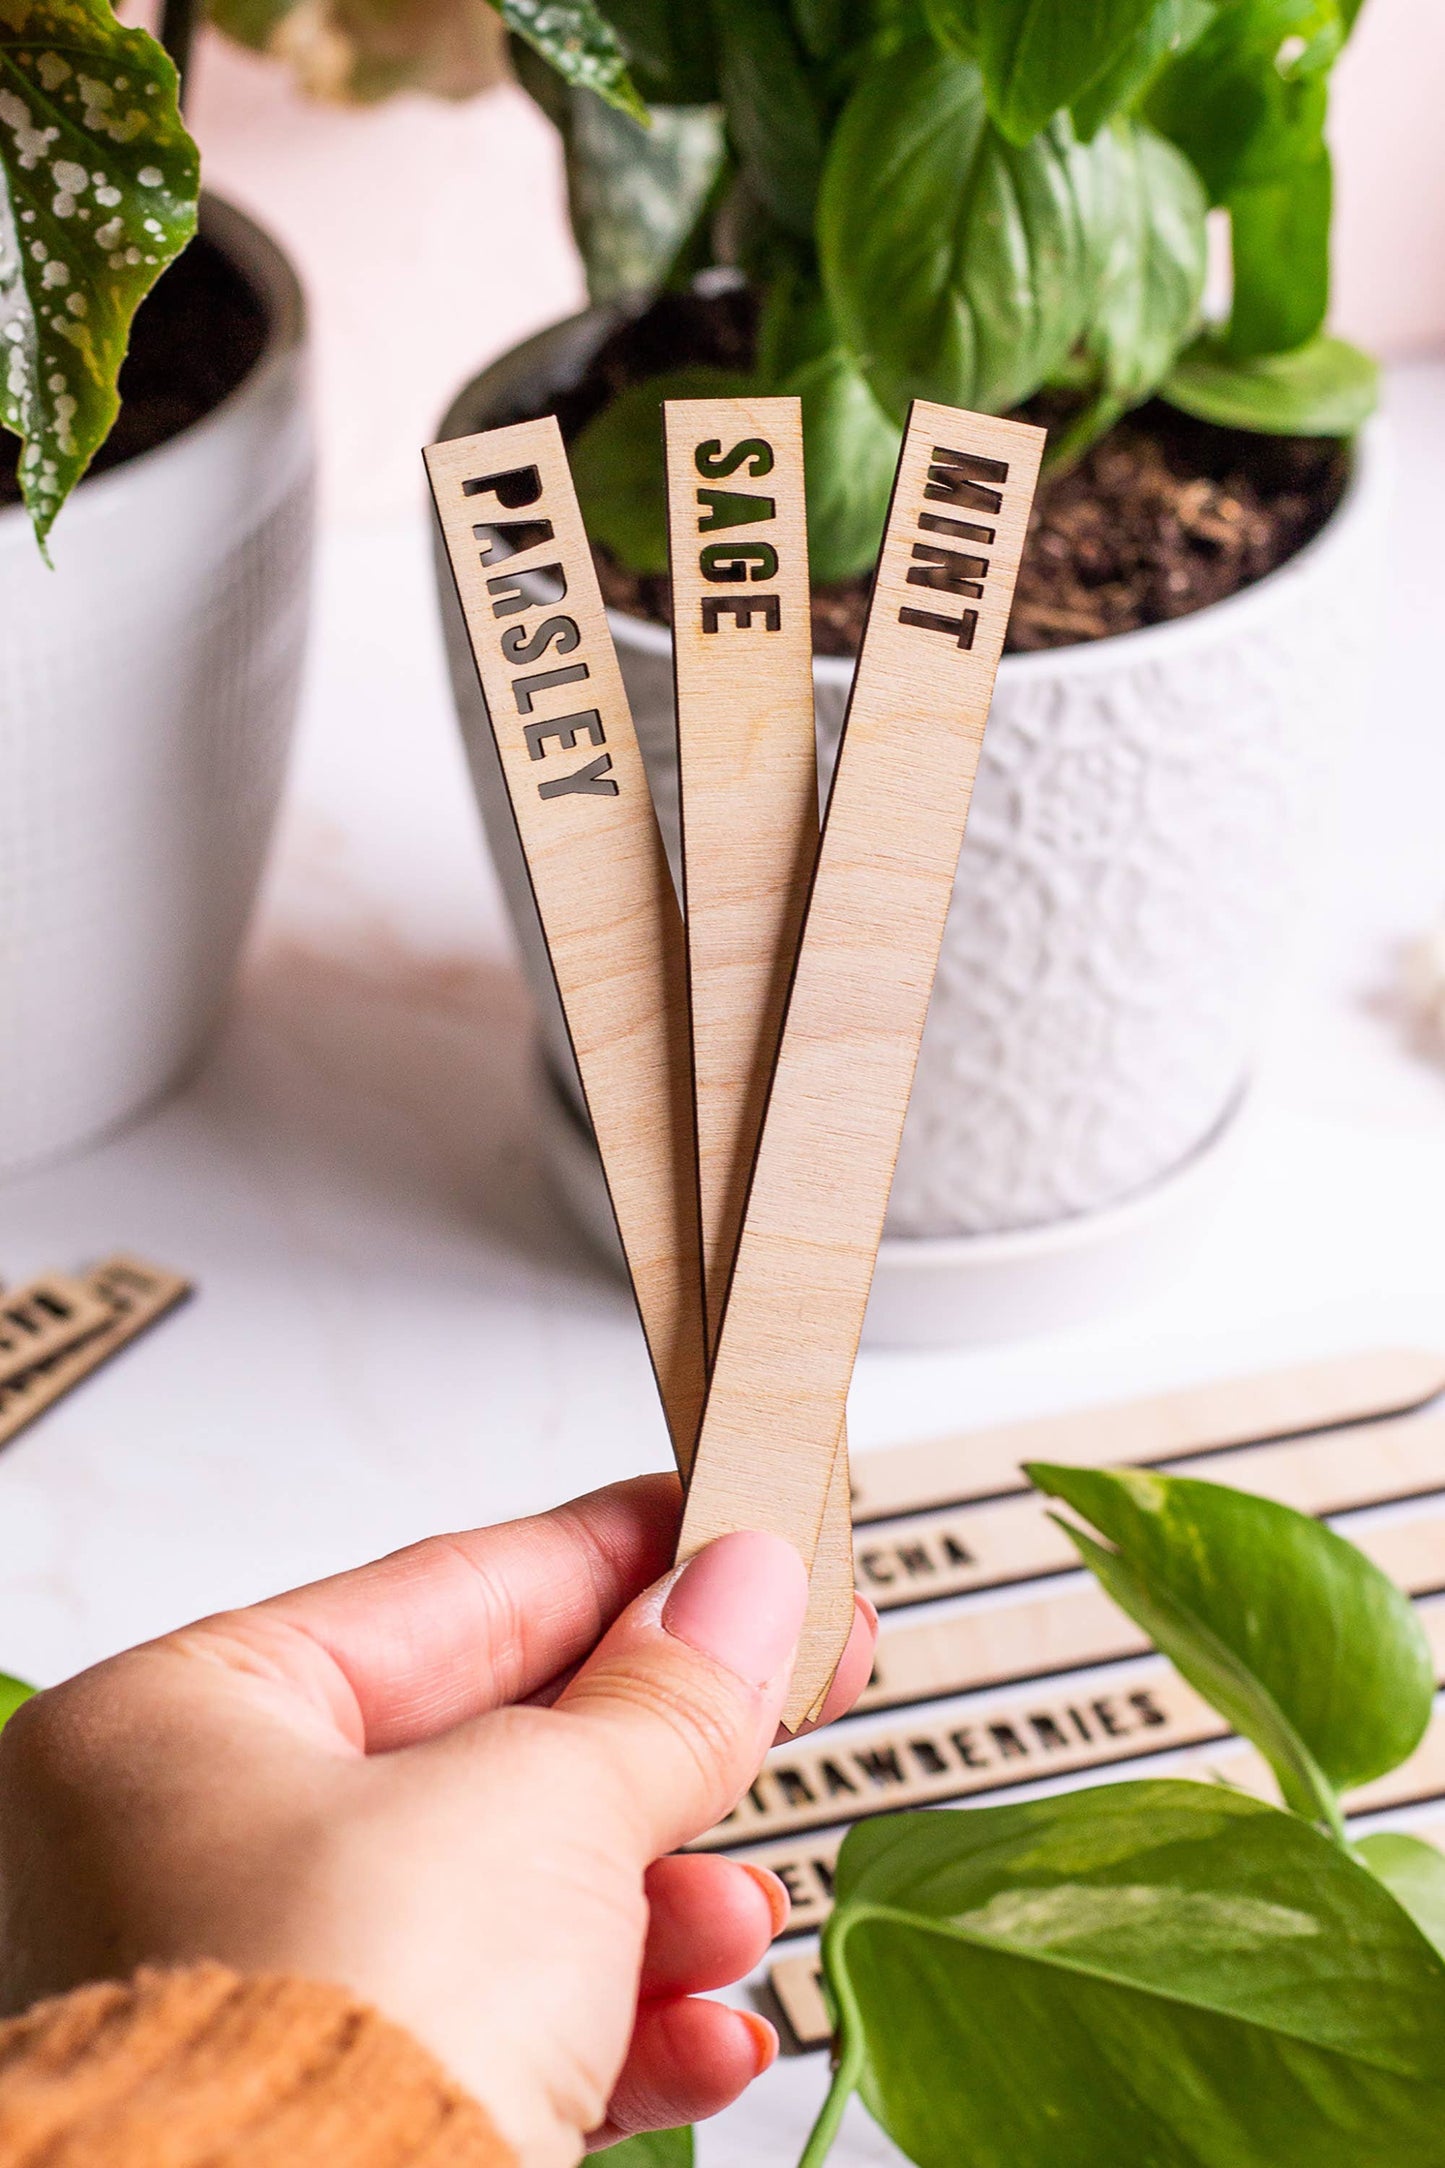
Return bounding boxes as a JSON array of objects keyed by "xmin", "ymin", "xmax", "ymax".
[{"xmin": 171, "ymin": 1476, "xmax": 680, "ymax": 1754}]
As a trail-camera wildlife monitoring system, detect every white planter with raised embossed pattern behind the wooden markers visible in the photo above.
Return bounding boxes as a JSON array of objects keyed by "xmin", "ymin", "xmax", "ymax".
[{"xmin": 442, "ymin": 310, "xmax": 1382, "ymax": 1342}]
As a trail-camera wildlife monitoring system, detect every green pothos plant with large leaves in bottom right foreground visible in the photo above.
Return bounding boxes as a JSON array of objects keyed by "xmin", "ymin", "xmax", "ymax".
[{"xmin": 609, "ymin": 1466, "xmax": 1445, "ymax": 2168}]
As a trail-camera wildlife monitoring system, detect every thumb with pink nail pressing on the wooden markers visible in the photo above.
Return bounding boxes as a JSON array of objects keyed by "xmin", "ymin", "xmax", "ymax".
[{"xmin": 555, "ymin": 1531, "xmax": 808, "ymax": 1864}]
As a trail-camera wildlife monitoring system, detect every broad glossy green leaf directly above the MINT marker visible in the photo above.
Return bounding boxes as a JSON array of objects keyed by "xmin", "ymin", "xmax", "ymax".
[{"xmin": 819, "ymin": 41, "xmax": 1092, "ymax": 421}]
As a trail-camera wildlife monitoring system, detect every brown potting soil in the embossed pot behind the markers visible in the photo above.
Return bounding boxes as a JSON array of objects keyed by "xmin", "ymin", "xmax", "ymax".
[{"xmin": 557, "ymin": 288, "xmax": 1348, "ymax": 655}]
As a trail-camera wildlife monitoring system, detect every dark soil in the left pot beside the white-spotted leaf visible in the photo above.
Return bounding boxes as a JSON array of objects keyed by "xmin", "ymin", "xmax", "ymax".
[{"xmin": 0, "ymin": 234, "xmax": 266, "ymax": 505}]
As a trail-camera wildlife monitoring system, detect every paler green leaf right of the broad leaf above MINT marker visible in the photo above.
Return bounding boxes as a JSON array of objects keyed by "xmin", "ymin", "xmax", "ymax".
[{"xmin": 1079, "ymin": 119, "xmax": 1209, "ymax": 416}]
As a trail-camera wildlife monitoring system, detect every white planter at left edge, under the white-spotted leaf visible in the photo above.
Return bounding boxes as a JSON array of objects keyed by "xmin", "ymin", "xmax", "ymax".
[{"xmin": 0, "ymin": 197, "xmax": 312, "ymax": 1175}]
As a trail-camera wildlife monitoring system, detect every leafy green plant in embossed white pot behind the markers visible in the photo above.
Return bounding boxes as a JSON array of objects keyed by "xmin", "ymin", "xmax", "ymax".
[{"xmin": 433, "ymin": 0, "xmax": 1378, "ymax": 1340}]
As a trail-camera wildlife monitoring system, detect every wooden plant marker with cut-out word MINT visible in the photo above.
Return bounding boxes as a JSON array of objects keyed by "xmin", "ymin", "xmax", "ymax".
[{"xmin": 680, "ymin": 401, "xmax": 1044, "ymax": 1726}]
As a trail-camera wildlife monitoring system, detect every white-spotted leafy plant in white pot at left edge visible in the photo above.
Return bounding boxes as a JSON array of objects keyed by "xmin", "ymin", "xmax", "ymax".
[{"xmin": 0, "ymin": 0, "xmax": 701, "ymax": 1175}]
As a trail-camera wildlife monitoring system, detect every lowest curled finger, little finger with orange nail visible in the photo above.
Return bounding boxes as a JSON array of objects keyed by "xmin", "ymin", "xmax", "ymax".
[{"xmin": 587, "ymin": 2001, "xmax": 778, "ymax": 2153}]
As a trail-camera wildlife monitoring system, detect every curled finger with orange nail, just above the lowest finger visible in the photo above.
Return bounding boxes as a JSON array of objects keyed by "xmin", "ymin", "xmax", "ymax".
[{"xmin": 641, "ymin": 1851, "xmax": 791, "ymax": 2001}]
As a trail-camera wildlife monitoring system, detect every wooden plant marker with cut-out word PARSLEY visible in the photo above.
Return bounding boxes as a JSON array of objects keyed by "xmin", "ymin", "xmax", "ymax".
[{"xmin": 425, "ymin": 416, "xmax": 704, "ymax": 1476}]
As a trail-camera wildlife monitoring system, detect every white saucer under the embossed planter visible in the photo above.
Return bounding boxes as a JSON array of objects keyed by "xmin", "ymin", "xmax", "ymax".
[{"xmin": 533, "ymin": 1062, "xmax": 1244, "ymax": 1348}]
